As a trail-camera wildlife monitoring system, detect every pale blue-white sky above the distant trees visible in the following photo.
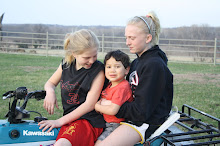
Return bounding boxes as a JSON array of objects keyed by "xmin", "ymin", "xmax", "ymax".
[{"xmin": 0, "ymin": 0, "xmax": 220, "ymax": 28}]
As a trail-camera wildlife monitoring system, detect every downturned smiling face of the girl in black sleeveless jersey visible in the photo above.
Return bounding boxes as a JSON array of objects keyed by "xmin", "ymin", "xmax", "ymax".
[{"xmin": 73, "ymin": 48, "xmax": 98, "ymax": 70}]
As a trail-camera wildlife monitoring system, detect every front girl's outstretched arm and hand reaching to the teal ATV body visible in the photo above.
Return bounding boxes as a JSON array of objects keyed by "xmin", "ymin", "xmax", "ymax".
[{"xmin": 38, "ymin": 71, "xmax": 105, "ymax": 132}]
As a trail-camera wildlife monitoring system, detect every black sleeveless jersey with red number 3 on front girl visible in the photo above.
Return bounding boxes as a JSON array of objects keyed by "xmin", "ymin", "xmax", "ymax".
[{"xmin": 60, "ymin": 61, "xmax": 105, "ymax": 128}]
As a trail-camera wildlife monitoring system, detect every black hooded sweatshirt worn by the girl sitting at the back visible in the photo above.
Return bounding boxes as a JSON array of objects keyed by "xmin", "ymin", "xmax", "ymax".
[{"xmin": 116, "ymin": 45, "xmax": 173, "ymax": 126}]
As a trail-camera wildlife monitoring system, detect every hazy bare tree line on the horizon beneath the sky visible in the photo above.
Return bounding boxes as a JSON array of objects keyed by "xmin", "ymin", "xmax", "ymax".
[{"xmin": 2, "ymin": 24, "xmax": 220, "ymax": 40}]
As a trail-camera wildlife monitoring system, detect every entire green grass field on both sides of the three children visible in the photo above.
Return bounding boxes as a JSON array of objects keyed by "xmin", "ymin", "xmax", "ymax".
[{"xmin": 0, "ymin": 53, "xmax": 220, "ymax": 128}]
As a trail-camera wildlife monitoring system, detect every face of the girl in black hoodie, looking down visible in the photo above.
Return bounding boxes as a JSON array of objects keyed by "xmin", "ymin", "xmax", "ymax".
[{"xmin": 125, "ymin": 25, "xmax": 149, "ymax": 56}]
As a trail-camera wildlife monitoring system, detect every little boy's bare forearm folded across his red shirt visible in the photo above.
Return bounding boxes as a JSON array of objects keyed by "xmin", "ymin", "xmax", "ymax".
[{"xmin": 95, "ymin": 101, "xmax": 121, "ymax": 115}]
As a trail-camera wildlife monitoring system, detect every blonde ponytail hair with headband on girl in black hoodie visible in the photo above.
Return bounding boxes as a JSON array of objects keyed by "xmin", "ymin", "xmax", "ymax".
[{"xmin": 127, "ymin": 11, "xmax": 161, "ymax": 46}]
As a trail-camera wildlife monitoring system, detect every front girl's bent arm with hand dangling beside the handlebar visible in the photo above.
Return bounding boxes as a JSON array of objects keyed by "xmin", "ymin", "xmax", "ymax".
[{"xmin": 44, "ymin": 64, "xmax": 62, "ymax": 114}]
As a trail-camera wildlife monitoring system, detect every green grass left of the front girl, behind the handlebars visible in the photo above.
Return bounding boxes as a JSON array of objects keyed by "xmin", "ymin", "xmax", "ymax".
[{"xmin": 0, "ymin": 53, "xmax": 62, "ymax": 119}]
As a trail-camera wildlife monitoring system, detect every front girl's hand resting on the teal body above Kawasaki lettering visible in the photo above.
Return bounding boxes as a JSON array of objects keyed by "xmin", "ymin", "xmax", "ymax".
[{"xmin": 38, "ymin": 120, "xmax": 62, "ymax": 132}]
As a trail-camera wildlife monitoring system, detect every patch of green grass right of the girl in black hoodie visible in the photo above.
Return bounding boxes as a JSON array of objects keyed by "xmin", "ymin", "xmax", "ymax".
[{"xmin": 169, "ymin": 63, "xmax": 220, "ymax": 118}]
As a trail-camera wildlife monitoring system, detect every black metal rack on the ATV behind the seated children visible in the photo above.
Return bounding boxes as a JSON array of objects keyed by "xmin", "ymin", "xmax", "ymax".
[{"xmin": 147, "ymin": 104, "xmax": 220, "ymax": 146}]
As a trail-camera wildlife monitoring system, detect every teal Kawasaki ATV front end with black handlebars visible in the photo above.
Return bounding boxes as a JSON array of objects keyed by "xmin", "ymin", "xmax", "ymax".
[{"xmin": 0, "ymin": 87, "xmax": 59, "ymax": 146}]
